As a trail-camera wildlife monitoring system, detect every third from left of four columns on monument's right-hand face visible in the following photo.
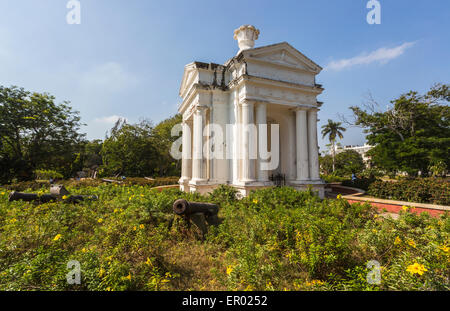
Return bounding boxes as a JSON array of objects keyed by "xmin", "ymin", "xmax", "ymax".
[{"xmin": 295, "ymin": 108, "xmax": 309, "ymax": 181}]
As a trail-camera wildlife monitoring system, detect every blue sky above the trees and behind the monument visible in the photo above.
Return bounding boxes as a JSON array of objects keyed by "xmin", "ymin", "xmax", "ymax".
[{"xmin": 0, "ymin": 0, "xmax": 450, "ymax": 150}]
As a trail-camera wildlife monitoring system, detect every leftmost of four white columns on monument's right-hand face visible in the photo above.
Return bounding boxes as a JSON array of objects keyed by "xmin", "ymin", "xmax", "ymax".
[{"xmin": 241, "ymin": 100, "xmax": 255, "ymax": 182}]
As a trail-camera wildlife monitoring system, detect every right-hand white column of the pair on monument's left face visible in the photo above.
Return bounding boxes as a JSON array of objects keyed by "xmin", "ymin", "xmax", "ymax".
[{"xmin": 192, "ymin": 106, "xmax": 206, "ymax": 181}]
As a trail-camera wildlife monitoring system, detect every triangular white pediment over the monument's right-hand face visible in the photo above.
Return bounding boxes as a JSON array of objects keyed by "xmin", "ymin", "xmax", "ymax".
[{"xmin": 242, "ymin": 42, "xmax": 322, "ymax": 74}]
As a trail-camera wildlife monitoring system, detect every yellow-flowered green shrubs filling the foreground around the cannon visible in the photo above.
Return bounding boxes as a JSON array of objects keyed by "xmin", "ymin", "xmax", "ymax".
[{"xmin": 0, "ymin": 182, "xmax": 450, "ymax": 291}]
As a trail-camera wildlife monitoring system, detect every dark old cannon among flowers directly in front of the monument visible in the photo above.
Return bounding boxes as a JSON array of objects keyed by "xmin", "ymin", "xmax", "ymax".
[{"xmin": 173, "ymin": 199, "xmax": 219, "ymax": 234}]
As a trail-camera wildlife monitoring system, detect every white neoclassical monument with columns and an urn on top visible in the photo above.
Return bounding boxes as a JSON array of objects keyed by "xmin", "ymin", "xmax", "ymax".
[{"xmin": 179, "ymin": 25, "xmax": 324, "ymax": 197}]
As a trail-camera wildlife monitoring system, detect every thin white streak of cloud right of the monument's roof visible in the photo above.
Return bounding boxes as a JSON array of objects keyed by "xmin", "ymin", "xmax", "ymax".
[{"xmin": 325, "ymin": 42, "xmax": 415, "ymax": 71}]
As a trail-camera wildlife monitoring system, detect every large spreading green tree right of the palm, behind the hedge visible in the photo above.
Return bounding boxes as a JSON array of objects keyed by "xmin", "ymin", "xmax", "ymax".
[{"xmin": 350, "ymin": 84, "xmax": 450, "ymax": 176}]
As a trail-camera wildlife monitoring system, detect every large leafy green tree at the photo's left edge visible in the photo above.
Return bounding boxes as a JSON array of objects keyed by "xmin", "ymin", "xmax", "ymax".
[{"xmin": 0, "ymin": 86, "xmax": 84, "ymax": 182}]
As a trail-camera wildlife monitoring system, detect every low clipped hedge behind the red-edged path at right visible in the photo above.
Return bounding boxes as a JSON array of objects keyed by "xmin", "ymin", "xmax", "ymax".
[{"xmin": 367, "ymin": 178, "xmax": 450, "ymax": 205}]
